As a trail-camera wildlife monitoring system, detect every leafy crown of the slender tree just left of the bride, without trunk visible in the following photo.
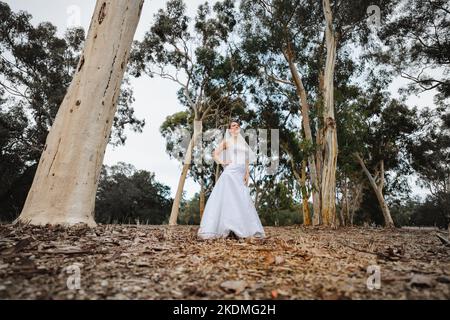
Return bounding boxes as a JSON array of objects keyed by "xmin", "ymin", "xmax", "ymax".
[{"xmin": 131, "ymin": 0, "xmax": 249, "ymax": 199}]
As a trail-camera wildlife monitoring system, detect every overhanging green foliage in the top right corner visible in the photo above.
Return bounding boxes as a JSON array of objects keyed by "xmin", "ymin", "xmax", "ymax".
[{"xmin": 374, "ymin": 0, "xmax": 450, "ymax": 106}]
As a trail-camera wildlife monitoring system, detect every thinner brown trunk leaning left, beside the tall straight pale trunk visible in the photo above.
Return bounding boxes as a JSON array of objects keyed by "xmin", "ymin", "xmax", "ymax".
[{"xmin": 283, "ymin": 44, "xmax": 321, "ymax": 225}]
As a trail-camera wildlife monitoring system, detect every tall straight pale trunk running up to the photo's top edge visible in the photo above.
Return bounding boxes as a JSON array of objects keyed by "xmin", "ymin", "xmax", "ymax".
[{"xmin": 321, "ymin": 0, "xmax": 338, "ymax": 226}]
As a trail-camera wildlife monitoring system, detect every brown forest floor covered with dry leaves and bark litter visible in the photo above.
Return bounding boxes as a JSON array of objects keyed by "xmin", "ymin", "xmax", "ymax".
[{"xmin": 0, "ymin": 225, "xmax": 450, "ymax": 299}]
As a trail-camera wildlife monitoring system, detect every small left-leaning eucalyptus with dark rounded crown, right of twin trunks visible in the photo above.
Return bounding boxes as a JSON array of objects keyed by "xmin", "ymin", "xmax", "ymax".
[{"xmin": 340, "ymin": 87, "xmax": 418, "ymax": 227}]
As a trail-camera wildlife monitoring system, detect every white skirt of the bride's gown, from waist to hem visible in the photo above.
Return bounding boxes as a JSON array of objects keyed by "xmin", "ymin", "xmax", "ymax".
[{"xmin": 198, "ymin": 164, "xmax": 265, "ymax": 239}]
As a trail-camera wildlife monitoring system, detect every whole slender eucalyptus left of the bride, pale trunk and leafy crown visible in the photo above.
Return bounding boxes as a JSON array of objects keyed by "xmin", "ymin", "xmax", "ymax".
[{"xmin": 133, "ymin": 0, "xmax": 253, "ymax": 225}]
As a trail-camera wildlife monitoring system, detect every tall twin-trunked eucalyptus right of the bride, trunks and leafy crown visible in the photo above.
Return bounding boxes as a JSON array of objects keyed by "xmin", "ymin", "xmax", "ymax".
[{"xmin": 241, "ymin": 0, "xmax": 395, "ymax": 225}]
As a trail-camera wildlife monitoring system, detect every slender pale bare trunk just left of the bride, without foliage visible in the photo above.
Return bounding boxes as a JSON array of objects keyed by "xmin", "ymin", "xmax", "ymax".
[{"xmin": 169, "ymin": 120, "xmax": 202, "ymax": 226}]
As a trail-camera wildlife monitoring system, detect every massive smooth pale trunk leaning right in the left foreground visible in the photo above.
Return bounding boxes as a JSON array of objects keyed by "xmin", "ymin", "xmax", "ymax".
[{"xmin": 18, "ymin": 0, "xmax": 144, "ymax": 226}]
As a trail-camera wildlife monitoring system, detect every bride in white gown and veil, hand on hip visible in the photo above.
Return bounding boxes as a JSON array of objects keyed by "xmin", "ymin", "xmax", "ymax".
[{"xmin": 198, "ymin": 120, "xmax": 265, "ymax": 239}]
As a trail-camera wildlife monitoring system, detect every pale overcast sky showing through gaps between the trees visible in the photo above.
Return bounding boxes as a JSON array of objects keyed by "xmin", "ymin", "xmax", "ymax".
[{"xmin": 3, "ymin": 0, "xmax": 433, "ymax": 198}]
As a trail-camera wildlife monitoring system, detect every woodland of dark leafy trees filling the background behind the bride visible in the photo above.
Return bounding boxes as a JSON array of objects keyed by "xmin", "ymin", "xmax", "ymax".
[{"xmin": 0, "ymin": 0, "xmax": 450, "ymax": 227}]
